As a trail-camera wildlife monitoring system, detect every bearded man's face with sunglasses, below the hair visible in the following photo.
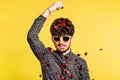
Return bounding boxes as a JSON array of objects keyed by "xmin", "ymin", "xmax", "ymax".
[{"xmin": 52, "ymin": 35, "xmax": 73, "ymax": 53}]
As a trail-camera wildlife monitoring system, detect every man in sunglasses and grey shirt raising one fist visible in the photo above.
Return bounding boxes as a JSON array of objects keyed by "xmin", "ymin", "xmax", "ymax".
[{"xmin": 27, "ymin": 2, "xmax": 90, "ymax": 80}]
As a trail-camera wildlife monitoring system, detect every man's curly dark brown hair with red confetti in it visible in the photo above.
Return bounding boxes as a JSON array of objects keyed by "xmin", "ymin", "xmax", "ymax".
[{"xmin": 50, "ymin": 18, "xmax": 74, "ymax": 36}]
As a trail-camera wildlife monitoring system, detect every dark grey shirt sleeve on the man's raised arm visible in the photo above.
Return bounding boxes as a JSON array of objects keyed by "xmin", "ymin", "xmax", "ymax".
[{"xmin": 27, "ymin": 15, "xmax": 46, "ymax": 60}]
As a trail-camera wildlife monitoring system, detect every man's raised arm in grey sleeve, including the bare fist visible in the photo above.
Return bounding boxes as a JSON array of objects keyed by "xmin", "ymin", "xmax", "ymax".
[{"xmin": 27, "ymin": 2, "xmax": 63, "ymax": 60}]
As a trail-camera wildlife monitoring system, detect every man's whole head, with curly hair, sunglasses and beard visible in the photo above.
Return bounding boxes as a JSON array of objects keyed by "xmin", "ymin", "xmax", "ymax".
[{"xmin": 50, "ymin": 18, "xmax": 74, "ymax": 53}]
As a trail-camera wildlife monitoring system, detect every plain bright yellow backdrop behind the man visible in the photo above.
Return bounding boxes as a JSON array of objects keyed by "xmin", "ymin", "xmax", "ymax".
[{"xmin": 0, "ymin": 0, "xmax": 120, "ymax": 80}]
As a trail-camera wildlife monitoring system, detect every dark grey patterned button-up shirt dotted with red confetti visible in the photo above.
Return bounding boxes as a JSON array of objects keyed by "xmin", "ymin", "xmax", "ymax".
[{"xmin": 27, "ymin": 15, "xmax": 90, "ymax": 80}]
